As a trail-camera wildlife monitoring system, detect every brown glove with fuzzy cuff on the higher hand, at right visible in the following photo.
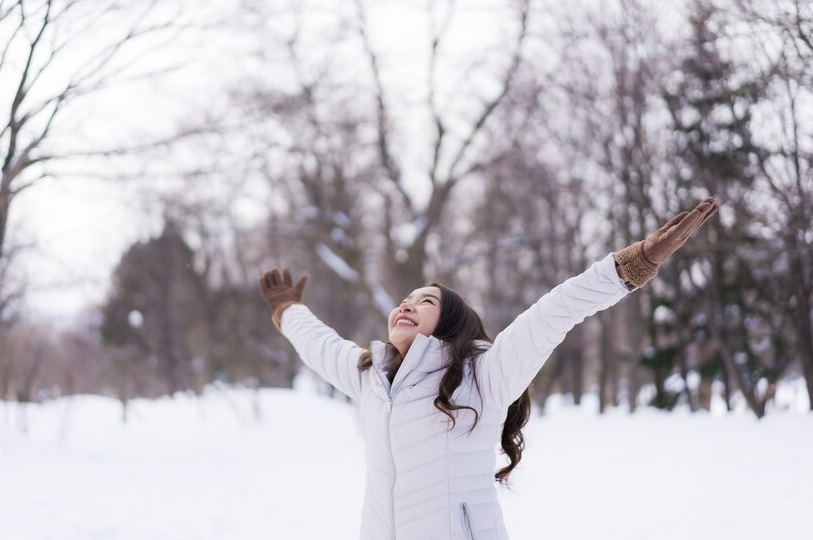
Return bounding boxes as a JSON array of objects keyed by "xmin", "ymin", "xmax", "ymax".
[{"xmin": 615, "ymin": 197, "xmax": 719, "ymax": 287}]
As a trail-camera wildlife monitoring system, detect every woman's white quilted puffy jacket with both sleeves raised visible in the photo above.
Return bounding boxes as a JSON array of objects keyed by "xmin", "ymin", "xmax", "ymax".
[{"xmin": 281, "ymin": 254, "xmax": 629, "ymax": 540}]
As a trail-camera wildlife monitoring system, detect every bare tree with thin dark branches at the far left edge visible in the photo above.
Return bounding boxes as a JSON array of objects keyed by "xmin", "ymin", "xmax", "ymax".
[{"xmin": 0, "ymin": 0, "xmax": 200, "ymax": 318}]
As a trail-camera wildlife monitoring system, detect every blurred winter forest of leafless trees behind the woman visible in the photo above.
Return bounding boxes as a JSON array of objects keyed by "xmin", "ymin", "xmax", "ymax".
[{"xmin": 0, "ymin": 0, "xmax": 813, "ymax": 417}]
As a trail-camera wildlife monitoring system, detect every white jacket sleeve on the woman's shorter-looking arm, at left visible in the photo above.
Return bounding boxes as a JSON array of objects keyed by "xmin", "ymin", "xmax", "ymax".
[{"xmin": 280, "ymin": 304, "xmax": 364, "ymax": 400}]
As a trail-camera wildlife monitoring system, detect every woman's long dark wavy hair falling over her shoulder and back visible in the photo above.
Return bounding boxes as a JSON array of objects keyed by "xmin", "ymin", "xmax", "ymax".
[{"xmin": 359, "ymin": 283, "xmax": 531, "ymax": 483}]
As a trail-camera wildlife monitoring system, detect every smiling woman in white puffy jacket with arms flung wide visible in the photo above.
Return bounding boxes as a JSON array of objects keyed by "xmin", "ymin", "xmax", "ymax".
[{"xmin": 260, "ymin": 198, "xmax": 717, "ymax": 540}]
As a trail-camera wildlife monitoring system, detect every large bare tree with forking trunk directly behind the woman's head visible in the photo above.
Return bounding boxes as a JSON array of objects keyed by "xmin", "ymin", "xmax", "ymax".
[{"xmin": 225, "ymin": 1, "xmax": 529, "ymax": 336}]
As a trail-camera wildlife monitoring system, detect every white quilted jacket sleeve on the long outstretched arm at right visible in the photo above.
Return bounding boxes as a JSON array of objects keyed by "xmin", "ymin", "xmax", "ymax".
[{"xmin": 477, "ymin": 253, "xmax": 630, "ymax": 408}]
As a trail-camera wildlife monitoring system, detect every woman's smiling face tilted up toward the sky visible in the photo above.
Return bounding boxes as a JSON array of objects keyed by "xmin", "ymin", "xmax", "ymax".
[{"xmin": 388, "ymin": 287, "xmax": 440, "ymax": 354}]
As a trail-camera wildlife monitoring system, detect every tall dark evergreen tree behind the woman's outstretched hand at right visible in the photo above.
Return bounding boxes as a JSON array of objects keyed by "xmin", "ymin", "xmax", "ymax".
[{"xmin": 664, "ymin": 0, "xmax": 792, "ymax": 416}]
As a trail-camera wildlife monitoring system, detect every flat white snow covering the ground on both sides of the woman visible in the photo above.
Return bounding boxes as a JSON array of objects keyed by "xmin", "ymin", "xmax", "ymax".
[{"xmin": 0, "ymin": 386, "xmax": 813, "ymax": 540}]
